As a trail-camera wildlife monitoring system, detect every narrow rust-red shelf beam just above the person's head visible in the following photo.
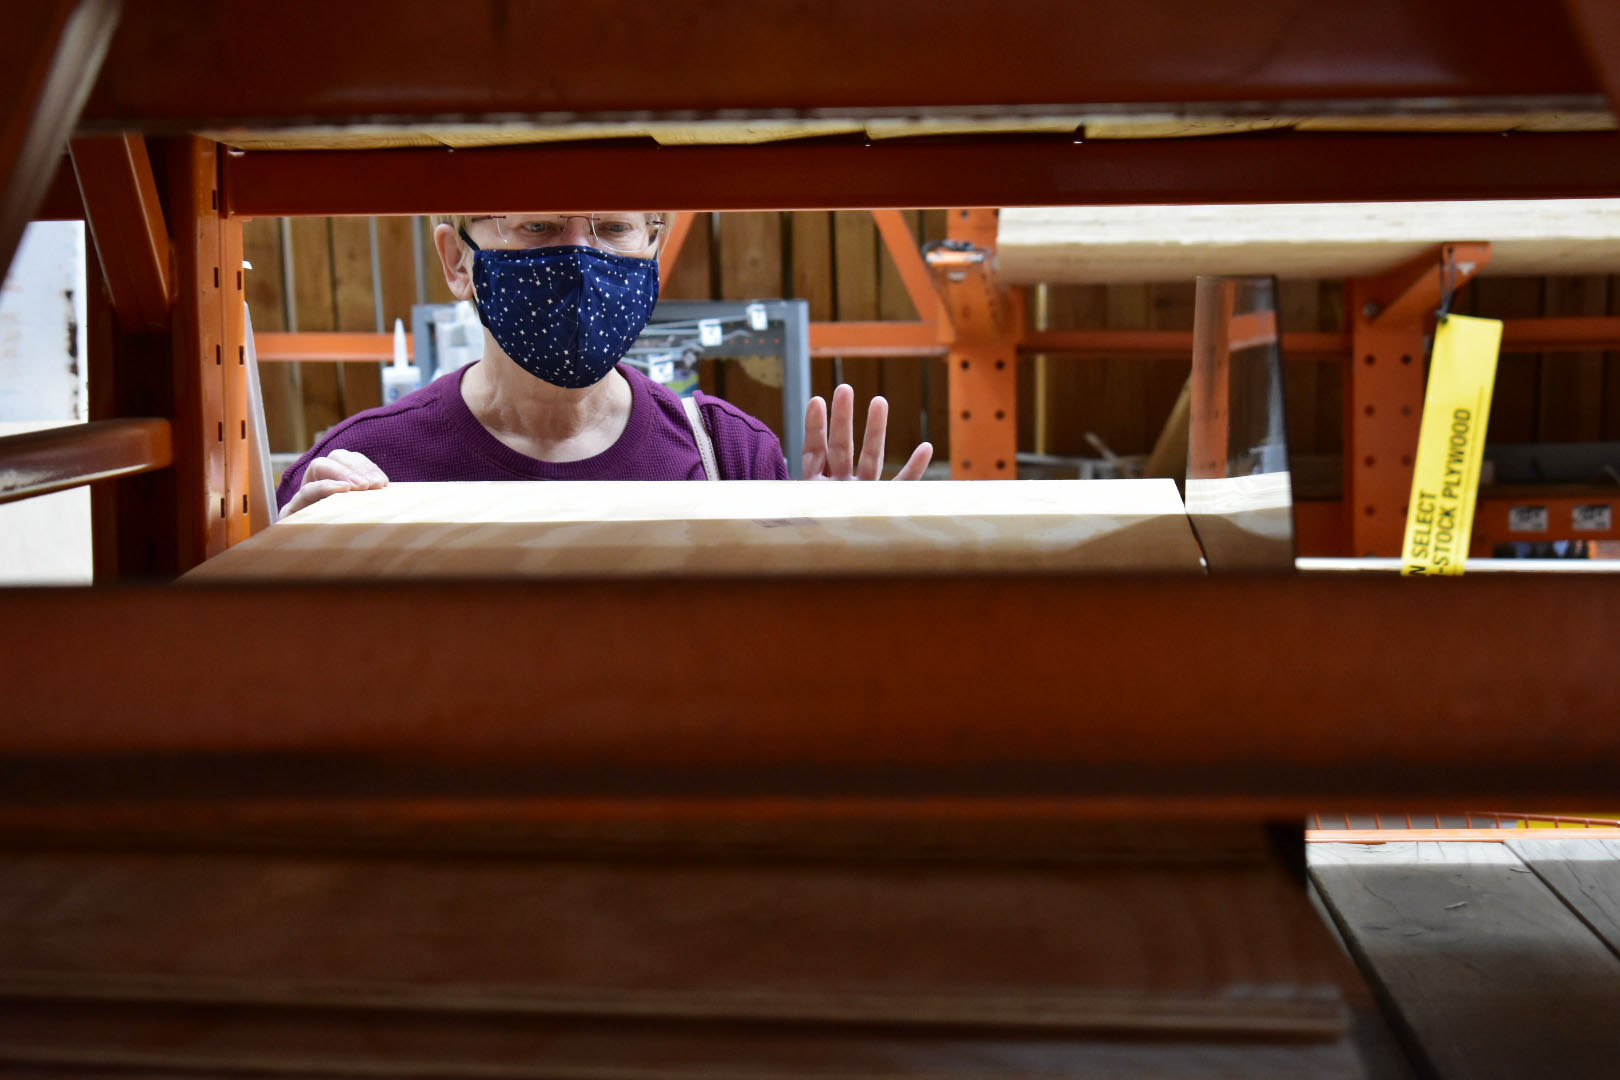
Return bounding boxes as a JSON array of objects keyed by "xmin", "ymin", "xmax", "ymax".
[{"xmin": 222, "ymin": 131, "xmax": 1620, "ymax": 217}]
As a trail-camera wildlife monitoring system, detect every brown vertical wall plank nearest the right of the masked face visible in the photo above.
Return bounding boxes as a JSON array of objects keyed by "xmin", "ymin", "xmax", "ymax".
[{"xmin": 719, "ymin": 212, "xmax": 784, "ymax": 437}]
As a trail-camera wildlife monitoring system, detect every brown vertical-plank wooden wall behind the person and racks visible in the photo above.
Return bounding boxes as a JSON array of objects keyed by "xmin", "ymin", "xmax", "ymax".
[{"xmin": 246, "ymin": 210, "xmax": 1620, "ymax": 476}]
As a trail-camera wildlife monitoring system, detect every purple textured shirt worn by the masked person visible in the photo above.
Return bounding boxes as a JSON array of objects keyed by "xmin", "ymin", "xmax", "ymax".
[{"xmin": 275, "ymin": 364, "xmax": 787, "ymax": 507}]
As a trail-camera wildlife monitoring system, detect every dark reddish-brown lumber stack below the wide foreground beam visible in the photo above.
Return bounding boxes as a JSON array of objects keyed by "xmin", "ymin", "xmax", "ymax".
[{"xmin": 0, "ymin": 819, "xmax": 1361, "ymax": 1080}]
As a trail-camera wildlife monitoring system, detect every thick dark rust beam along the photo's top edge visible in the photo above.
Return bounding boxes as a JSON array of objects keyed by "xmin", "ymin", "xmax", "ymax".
[{"xmin": 72, "ymin": 0, "xmax": 1602, "ymax": 127}]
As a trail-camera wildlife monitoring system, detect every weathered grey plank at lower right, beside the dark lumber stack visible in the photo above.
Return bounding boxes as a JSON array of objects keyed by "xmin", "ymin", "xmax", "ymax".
[{"xmin": 1309, "ymin": 842, "xmax": 1620, "ymax": 1080}]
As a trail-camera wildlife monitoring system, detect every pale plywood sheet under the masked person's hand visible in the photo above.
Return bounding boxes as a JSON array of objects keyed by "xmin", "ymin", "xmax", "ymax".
[{"xmin": 188, "ymin": 479, "xmax": 1200, "ymax": 581}]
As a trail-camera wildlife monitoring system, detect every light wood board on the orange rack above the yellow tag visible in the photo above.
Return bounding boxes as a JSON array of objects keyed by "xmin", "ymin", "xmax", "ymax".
[{"xmin": 996, "ymin": 199, "xmax": 1620, "ymax": 283}]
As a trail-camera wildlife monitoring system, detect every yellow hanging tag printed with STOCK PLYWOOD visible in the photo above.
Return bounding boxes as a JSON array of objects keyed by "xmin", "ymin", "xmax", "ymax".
[{"xmin": 1401, "ymin": 316, "xmax": 1502, "ymax": 575}]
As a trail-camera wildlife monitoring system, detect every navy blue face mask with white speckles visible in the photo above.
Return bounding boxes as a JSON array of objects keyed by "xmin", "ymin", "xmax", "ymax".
[{"xmin": 462, "ymin": 228, "xmax": 658, "ymax": 389}]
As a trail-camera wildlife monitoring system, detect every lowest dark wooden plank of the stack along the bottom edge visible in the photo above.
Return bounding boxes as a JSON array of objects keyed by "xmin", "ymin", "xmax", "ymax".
[{"xmin": 0, "ymin": 1002, "xmax": 1361, "ymax": 1080}]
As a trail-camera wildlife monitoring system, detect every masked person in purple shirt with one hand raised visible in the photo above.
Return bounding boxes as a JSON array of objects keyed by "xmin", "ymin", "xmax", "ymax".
[{"xmin": 277, "ymin": 214, "xmax": 933, "ymax": 517}]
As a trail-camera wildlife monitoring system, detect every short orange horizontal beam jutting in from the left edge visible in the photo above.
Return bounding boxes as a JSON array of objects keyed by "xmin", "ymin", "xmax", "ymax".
[{"xmin": 0, "ymin": 418, "xmax": 175, "ymax": 502}]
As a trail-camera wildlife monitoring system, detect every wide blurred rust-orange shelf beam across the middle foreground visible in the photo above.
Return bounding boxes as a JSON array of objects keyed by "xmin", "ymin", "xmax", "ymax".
[{"xmin": 0, "ymin": 575, "xmax": 1620, "ymax": 816}]
